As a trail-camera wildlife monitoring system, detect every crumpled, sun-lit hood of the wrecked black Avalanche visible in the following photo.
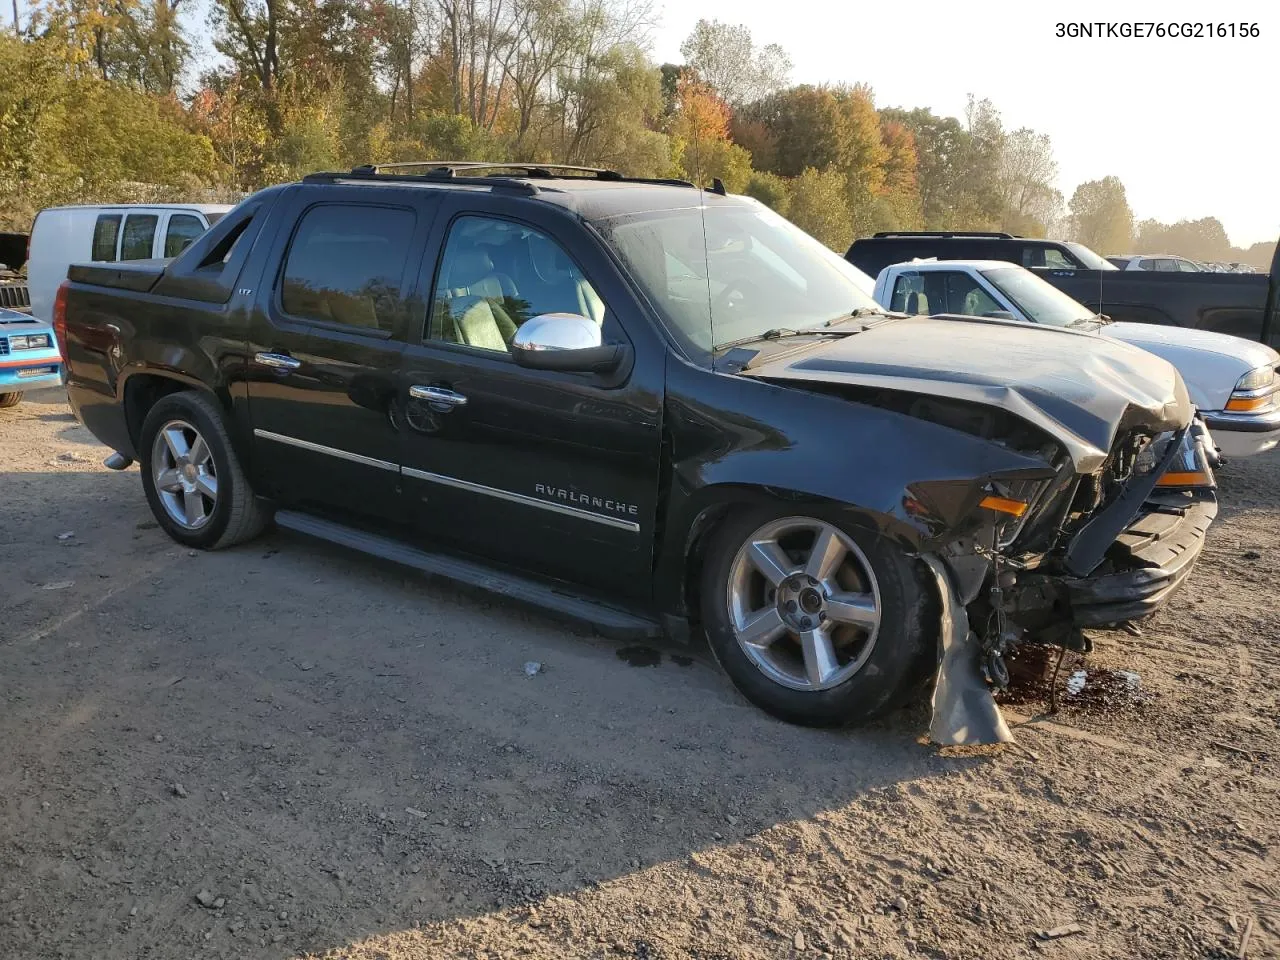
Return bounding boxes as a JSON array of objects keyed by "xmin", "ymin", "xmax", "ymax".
[{"xmin": 744, "ymin": 316, "xmax": 1192, "ymax": 474}]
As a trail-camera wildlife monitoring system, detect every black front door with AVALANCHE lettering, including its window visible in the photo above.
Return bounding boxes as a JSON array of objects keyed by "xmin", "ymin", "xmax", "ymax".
[{"xmin": 398, "ymin": 193, "xmax": 664, "ymax": 600}]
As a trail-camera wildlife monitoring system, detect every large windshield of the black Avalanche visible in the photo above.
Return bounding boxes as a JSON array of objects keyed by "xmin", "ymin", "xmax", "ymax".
[{"xmin": 593, "ymin": 197, "xmax": 882, "ymax": 353}]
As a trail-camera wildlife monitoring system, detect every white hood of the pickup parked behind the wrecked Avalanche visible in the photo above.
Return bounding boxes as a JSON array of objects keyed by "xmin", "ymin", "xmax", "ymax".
[{"xmin": 1098, "ymin": 323, "xmax": 1280, "ymax": 411}]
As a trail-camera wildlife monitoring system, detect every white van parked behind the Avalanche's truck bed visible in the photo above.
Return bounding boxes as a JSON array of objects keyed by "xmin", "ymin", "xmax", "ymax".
[{"xmin": 27, "ymin": 204, "xmax": 232, "ymax": 323}]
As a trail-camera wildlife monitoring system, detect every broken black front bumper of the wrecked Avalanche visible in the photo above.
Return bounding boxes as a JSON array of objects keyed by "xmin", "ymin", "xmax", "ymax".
[{"xmin": 1062, "ymin": 495, "xmax": 1217, "ymax": 627}]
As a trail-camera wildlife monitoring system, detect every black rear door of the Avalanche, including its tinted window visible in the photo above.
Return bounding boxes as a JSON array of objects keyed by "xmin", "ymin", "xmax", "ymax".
[{"xmin": 247, "ymin": 184, "xmax": 434, "ymax": 522}]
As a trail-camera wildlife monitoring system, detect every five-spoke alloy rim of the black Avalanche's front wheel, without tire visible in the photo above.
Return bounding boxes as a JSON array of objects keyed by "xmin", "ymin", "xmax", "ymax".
[{"xmin": 726, "ymin": 517, "xmax": 881, "ymax": 691}]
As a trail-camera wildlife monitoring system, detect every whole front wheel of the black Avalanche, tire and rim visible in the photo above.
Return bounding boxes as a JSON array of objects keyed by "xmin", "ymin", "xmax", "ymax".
[{"xmin": 701, "ymin": 509, "xmax": 937, "ymax": 727}]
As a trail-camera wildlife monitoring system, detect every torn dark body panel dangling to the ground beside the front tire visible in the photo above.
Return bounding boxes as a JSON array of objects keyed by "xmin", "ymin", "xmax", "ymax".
[{"xmin": 924, "ymin": 556, "xmax": 1014, "ymax": 746}]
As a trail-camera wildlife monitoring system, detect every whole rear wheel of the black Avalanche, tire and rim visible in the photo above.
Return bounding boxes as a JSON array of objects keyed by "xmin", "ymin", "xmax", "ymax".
[{"xmin": 138, "ymin": 390, "xmax": 270, "ymax": 550}]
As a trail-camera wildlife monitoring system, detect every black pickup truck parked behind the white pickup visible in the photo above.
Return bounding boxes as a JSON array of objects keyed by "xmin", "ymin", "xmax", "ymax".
[{"xmin": 845, "ymin": 232, "xmax": 1280, "ymax": 347}]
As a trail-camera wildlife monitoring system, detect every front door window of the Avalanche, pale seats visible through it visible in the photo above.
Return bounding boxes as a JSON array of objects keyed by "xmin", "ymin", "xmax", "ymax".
[{"xmin": 424, "ymin": 216, "xmax": 605, "ymax": 353}]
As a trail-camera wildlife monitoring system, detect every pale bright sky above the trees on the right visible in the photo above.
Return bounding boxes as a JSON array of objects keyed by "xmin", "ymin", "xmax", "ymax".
[{"xmin": 653, "ymin": 0, "xmax": 1280, "ymax": 252}]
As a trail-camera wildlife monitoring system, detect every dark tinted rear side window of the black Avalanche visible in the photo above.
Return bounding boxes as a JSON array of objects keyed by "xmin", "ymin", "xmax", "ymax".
[{"xmin": 280, "ymin": 204, "xmax": 415, "ymax": 333}]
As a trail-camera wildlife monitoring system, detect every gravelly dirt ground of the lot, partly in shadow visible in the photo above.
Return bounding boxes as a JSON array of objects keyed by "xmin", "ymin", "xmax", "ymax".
[{"xmin": 0, "ymin": 392, "xmax": 1280, "ymax": 960}]
